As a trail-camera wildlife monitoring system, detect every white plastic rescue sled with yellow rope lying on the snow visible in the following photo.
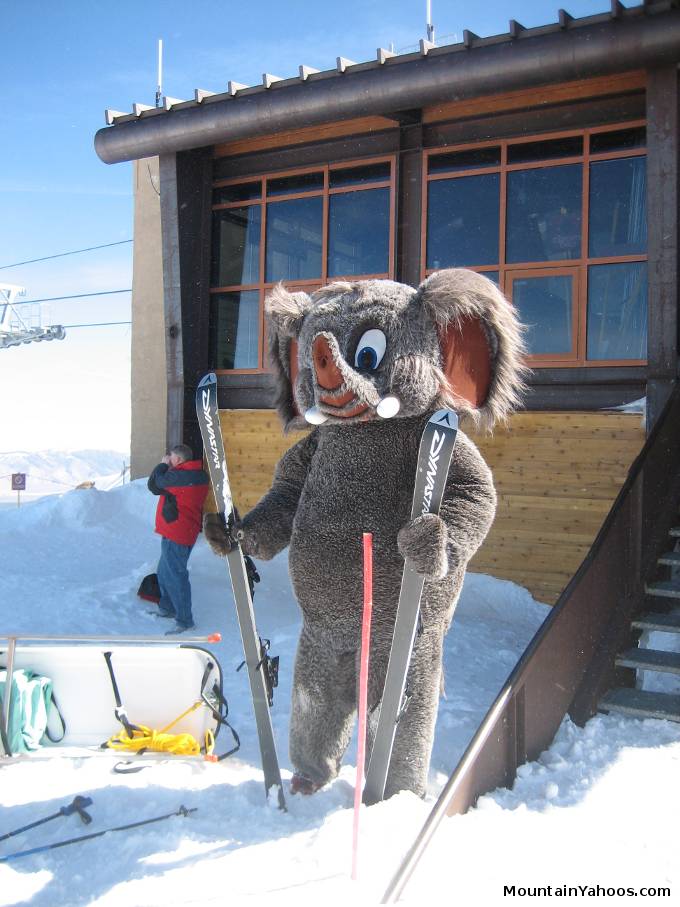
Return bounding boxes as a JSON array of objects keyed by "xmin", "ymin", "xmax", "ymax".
[{"xmin": 0, "ymin": 638, "xmax": 231, "ymax": 758}]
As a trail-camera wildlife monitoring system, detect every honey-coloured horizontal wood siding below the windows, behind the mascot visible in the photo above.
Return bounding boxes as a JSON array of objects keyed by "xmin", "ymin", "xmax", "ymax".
[{"xmin": 220, "ymin": 410, "xmax": 645, "ymax": 604}]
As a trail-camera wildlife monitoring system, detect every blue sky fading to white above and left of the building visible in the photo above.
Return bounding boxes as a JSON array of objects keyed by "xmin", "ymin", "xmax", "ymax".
[{"xmin": 0, "ymin": 0, "xmax": 624, "ymax": 451}]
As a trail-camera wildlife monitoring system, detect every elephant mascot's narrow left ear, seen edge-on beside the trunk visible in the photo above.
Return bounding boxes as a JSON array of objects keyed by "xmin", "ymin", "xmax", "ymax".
[{"xmin": 264, "ymin": 284, "xmax": 311, "ymax": 431}]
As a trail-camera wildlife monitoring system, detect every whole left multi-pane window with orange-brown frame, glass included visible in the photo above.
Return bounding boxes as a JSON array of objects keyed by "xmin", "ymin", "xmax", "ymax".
[{"xmin": 210, "ymin": 158, "xmax": 395, "ymax": 372}]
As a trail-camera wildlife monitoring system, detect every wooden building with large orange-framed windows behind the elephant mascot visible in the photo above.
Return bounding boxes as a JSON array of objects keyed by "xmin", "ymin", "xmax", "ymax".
[{"xmin": 96, "ymin": 7, "xmax": 680, "ymax": 601}]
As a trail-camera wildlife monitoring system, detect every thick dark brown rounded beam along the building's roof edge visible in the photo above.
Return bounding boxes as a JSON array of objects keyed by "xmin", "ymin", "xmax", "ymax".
[{"xmin": 95, "ymin": 0, "xmax": 680, "ymax": 163}]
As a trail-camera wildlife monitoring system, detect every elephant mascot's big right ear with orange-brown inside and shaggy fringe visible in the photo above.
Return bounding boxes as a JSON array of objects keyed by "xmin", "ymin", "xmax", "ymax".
[{"xmin": 417, "ymin": 268, "xmax": 527, "ymax": 428}]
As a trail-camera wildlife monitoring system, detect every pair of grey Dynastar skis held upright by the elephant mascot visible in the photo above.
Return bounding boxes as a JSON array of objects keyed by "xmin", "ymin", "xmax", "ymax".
[{"xmin": 196, "ymin": 373, "xmax": 458, "ymax": 809}]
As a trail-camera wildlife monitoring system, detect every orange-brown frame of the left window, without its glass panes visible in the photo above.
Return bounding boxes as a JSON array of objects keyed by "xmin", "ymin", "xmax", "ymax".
[{"xmin": 208, "ymin": 154, "xmax": 398, "ymax": 375}]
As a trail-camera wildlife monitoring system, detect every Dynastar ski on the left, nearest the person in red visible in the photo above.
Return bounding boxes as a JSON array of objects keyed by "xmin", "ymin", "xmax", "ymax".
[{"xmin": 196, "ymin": 373, "xmax": 286, "ymax": 809}]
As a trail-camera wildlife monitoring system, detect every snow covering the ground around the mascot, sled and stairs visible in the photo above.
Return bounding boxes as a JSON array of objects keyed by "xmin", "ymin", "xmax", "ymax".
[{"xmin": 0, "ymin": 470, "xmax": 680, "ymax": 907}]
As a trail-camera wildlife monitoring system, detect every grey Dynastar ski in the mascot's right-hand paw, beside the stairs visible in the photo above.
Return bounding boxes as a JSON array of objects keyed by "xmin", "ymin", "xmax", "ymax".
[{"xmin": 363, "ymin": 409, "xmax": 458, "ymax": 805}]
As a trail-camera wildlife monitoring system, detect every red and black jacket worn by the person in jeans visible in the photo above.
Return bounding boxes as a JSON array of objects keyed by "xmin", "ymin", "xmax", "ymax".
[{"xmin": 147, "ymin": 460, "xmax": 208, "ymax": 545}]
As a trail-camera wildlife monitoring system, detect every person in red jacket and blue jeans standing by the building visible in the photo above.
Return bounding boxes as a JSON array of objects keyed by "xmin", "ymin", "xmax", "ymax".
[{"xmin": 147, "ymin": 444, "xmax": 208, "ymax": 636}]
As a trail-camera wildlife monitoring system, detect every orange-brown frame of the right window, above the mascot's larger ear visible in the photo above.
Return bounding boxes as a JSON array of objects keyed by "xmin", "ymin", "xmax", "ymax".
[{"xmin": 420, "ymin": 119, "xmax": 649, "ymax": 368}]
